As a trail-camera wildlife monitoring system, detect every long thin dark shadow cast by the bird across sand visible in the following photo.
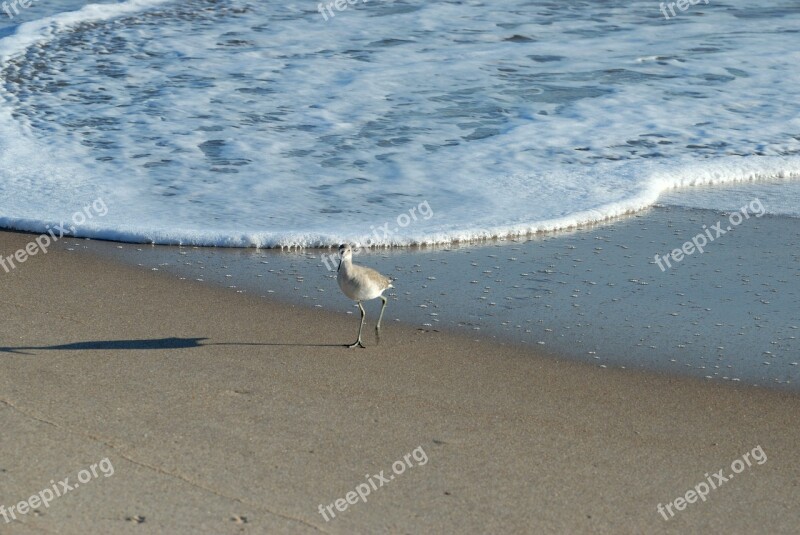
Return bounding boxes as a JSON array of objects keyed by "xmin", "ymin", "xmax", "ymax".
[{"xmin": 0, "ymin": 337, "xmax": 350, "ymax": 355}]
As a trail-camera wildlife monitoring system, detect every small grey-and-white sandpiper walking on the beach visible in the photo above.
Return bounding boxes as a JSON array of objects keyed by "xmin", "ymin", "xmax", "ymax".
[{"xmin": 336, "ymin": 244, "xmax": 394, "ymax": 347}]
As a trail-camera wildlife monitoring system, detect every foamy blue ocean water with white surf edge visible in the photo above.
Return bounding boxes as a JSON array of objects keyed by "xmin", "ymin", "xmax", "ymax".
[{"xmin": 0, "ymin": 0, "xmax": 800, "ymax": 247}]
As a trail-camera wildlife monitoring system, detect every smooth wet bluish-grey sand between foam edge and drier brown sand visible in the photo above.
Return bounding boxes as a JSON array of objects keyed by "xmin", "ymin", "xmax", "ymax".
[{"xmin": 50, "ymin": 206, "xmax": 800, "ymax": 392}]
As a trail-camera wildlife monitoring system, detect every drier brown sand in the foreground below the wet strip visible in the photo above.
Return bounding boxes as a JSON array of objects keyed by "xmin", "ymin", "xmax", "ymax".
[{"xmin": 0, "ymin": 228, "xmax": 800, "ymax": 534}]
